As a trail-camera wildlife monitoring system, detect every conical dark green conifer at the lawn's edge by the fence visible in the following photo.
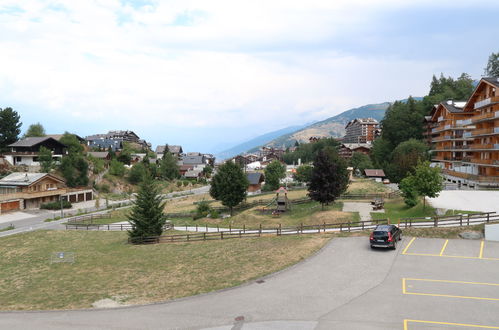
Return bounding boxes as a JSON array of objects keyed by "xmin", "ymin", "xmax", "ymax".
[{"xmin": 127, "ymin": 176, "xmax": 166, "ymax": 242}]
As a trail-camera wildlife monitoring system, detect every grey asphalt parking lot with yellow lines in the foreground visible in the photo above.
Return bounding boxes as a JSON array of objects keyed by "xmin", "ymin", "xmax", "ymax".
[{"xmin": 0, "ymin": 237, "xmax": 499, "ymax": 330}]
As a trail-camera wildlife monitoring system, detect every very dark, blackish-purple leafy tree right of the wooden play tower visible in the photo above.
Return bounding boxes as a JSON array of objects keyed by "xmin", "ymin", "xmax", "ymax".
[{"xmin": 308, "ymin": 149, "xmax": 349, "ymax": 210}]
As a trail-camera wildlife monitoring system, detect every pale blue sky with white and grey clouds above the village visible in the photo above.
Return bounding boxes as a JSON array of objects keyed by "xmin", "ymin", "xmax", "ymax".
[{"xmin": 0, "ymin": 0, "xmax": 499, "ymax": 152}]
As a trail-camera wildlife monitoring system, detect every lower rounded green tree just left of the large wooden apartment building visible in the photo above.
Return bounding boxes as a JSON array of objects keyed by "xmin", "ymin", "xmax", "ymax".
[{"xmin": 386, "ymin": 139, "xmax": 428, "ymax": 182}]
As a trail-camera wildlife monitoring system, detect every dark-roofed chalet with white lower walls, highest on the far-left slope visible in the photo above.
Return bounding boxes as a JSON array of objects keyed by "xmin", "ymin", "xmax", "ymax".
[{"xmin": 5, "ymin": 136, "xmax": 66, "ymax": 166}]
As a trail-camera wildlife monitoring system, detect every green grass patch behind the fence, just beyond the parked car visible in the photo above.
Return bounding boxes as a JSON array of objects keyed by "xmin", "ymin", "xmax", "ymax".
[{"xmin": 371, "ymin": 198, "xmax": 436, "ymax": 223}]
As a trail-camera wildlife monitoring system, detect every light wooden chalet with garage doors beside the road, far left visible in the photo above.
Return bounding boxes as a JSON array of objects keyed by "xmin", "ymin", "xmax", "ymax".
[{"xmin": 0, "ymin": 172, "xmax": 93, "ymax": 213}]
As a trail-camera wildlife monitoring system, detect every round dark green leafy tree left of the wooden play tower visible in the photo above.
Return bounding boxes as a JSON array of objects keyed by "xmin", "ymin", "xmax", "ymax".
[{"xmin": 210, "ymin": 162, "xmax": 249, "ymax": 215}]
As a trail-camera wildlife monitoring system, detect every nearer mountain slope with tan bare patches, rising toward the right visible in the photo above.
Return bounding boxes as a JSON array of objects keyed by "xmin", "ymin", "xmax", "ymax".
[{"xmin": 260, "ymin": 102, "xmax": 391, "ymax": 152}]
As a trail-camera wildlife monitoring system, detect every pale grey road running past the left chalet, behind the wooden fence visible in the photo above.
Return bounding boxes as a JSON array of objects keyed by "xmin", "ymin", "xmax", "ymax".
[{"xmin": 0, "ymin": 186, "xmax": 210, "ymax": 237}]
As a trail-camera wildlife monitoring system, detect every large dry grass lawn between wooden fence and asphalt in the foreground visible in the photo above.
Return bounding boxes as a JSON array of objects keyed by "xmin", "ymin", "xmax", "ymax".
[{"xmin": 0, "ymin": 231, "xmax": 331, "ymax": 310}]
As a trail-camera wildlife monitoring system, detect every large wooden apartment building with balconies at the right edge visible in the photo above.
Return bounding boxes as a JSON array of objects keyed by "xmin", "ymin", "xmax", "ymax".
[{"xmin": 427, "ymin": 78, "xmax": 499, "ymax": 188}]
